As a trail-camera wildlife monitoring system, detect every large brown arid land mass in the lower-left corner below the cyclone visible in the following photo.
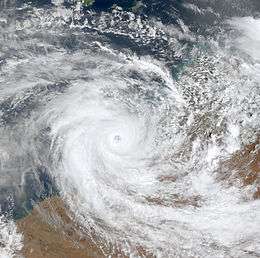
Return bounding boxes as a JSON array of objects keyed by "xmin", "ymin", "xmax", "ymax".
[{"xmin": 17, "ymin": 197, "xmax": 105, "ymax": 258}]
